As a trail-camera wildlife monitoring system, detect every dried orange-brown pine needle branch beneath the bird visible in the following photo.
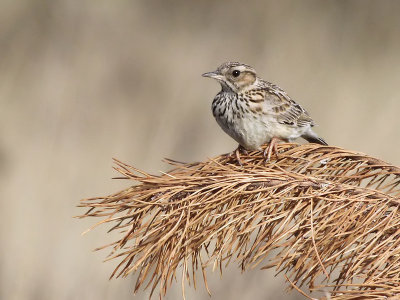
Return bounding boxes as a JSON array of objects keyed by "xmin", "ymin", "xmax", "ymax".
[{"xmin": 80, "ymin": 144, "xmax": 400, "ymax": 299}]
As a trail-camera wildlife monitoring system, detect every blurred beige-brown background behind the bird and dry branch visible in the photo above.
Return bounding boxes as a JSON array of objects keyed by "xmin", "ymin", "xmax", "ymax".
[{"xmin": 0, "ymin": 0, "xmax": 400, "ymax": 299}]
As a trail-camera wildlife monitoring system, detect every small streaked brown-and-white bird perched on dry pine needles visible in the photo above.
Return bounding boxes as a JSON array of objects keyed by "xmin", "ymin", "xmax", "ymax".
[{"xmin": 202, "ymin": 61, "xmax": 327, "ymax": 165}]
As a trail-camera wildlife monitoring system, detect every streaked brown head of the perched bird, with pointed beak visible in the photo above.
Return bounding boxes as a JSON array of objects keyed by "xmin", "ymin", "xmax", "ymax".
[{"xmin": 202, "ymin": 62, "xmax": 257, "ymax": 93}]
